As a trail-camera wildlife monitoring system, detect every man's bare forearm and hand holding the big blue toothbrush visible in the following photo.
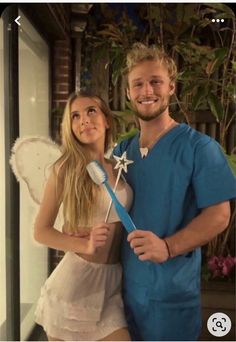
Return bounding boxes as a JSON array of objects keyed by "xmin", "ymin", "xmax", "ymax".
[{"xmin": 128, "ymin": 201, "xmax": 230, "ymax": 263}]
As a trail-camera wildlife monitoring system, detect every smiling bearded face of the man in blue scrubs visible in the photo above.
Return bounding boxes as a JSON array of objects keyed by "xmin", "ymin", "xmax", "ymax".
[{"xmin": 127, "ymin": 61, "xmax": 175, "ymax": 121}]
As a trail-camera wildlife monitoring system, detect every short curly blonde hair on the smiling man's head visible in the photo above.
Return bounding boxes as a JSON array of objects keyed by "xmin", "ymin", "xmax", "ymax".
[{"xmin": 125, "ymin": 43, "xmax": 177, "ymax": 82}]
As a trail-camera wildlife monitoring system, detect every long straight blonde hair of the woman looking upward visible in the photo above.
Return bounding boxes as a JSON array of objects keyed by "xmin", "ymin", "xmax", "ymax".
[{"xmin": 56, "ymin": 93, "xmax": 115, "ymax": 233}]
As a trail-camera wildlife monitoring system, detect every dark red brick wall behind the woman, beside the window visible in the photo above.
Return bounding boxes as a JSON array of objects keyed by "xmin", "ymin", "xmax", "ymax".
[{"xmin": 50, "ymin": 40, "xmax": 73, "ymax": 271}]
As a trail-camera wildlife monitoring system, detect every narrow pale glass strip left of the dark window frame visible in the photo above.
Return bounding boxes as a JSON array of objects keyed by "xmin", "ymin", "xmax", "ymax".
[{"xmin": 0, "ymin": 19, "xmax": 6, "ymax": 341}]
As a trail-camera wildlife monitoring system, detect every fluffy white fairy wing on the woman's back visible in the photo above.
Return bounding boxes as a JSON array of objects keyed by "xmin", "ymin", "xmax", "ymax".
[{"xmin": 10, "ymin": 136, "xmax": 61, "ymax": 204}]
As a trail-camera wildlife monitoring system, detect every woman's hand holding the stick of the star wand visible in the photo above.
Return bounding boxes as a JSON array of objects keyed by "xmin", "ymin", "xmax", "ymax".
[{"xmin": 86, "ymin": 222, "xmax": 110, "ymax": 255}]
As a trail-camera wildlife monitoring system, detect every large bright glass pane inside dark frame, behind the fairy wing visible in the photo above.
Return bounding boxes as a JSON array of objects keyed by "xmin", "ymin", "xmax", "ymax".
[{"xmin": 19, "ymin": 12, "xmax": 49, "ymax": 340}]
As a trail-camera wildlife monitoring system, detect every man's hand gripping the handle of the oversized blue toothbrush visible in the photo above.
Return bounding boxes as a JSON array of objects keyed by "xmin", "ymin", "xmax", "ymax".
[{"xmin": 127, "ymin": 229, "xmax": 169, "ymax": 263}]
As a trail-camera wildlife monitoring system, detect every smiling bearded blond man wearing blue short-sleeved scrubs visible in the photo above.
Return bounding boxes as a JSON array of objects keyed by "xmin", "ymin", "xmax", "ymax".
[{"xmin": 114, "ymin": 43, "xmax": 236, "ymax": 341}]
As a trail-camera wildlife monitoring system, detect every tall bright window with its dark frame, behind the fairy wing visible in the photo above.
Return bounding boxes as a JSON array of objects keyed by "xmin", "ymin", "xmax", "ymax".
[{"xmin": 0, "ymin": 5, "xmax": 49, "ymax": 341}]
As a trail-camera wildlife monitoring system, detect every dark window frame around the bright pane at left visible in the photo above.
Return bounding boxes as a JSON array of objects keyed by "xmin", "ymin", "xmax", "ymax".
[{"xmin": 2, "ymin": 5, "xmax": 52, "ymax": 341}]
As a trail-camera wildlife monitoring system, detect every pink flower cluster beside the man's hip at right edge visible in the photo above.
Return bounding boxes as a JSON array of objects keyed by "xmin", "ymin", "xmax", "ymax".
[{"xmin": 208, "ymin": 255, "xmax": 236, "ymax": 278}]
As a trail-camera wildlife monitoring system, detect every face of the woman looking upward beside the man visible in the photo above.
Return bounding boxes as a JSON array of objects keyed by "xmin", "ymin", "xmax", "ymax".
[{"xmin": 70, "ymin": 97, "xmax": 109, "ymax": 146}]
